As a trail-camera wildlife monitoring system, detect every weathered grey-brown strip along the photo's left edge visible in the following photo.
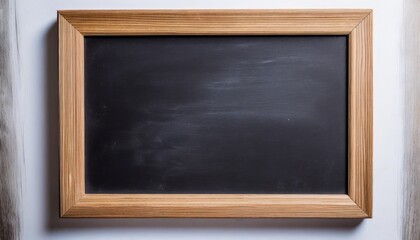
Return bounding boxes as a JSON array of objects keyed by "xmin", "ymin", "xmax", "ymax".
[{"xmin": 0, "ymin": 0, "xmax": 23, "ymax": 240}]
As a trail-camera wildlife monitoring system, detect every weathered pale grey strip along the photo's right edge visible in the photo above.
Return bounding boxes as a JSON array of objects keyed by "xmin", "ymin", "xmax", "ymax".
[{"xmin": 402, "ymin": 0, "xmax": 420, "ymax": 240}]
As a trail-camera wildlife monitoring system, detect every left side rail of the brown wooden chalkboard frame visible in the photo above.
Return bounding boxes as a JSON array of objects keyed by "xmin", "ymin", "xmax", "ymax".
[{"xmin": 58, "ymin": 16, "xmax": 85, "ymax": 213}]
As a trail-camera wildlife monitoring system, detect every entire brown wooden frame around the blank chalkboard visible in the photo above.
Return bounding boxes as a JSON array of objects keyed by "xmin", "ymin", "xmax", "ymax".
[{"xmin": 58, "ymin": 10, "xmax": 373, "ymax": 218}]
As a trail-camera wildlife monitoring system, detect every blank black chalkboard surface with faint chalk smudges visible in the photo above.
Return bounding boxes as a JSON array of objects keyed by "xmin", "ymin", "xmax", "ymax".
[{"xmin": 84, "ymin": 36, "xmax": 348, "ymax": 194}]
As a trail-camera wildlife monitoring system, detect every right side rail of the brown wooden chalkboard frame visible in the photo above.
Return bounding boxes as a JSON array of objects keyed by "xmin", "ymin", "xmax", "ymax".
[{"xmin": 349, "ymin": 11, "xmax": 373, "ymax": 217}]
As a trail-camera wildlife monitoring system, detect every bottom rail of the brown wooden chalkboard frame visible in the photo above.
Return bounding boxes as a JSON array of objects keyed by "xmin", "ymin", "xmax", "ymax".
[{"xmin": 65, "ymin": 194, "xmax": 367, "ymax": 218}]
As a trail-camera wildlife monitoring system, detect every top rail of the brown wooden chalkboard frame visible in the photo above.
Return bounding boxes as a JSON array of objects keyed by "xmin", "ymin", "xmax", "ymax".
[{"xmin": 59, "ymin": 10, "xmax": 369, "ymax": 35}]
